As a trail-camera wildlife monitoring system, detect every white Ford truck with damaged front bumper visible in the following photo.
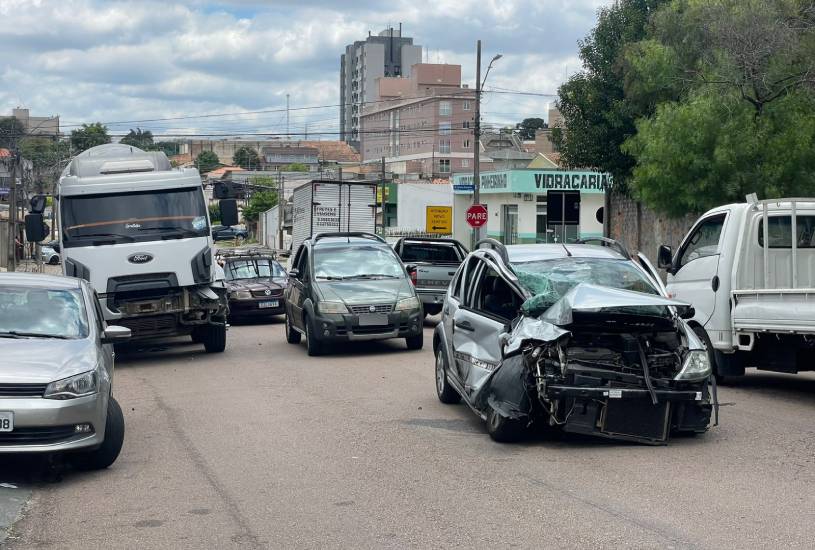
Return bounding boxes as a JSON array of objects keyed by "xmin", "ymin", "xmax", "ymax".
[{"xmin": 57, "ymin": 144, "xmax": 228, "ymax": 352}]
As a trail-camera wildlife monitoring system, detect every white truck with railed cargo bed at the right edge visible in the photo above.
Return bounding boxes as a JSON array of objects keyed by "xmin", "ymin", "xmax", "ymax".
[{"xmin": 659, "ymin": 195, "xmax": 815, "ymax": 380}]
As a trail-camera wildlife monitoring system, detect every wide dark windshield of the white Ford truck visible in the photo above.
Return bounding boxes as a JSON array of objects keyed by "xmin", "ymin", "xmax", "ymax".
[{"xmin": 60, "ymin": 187, "xmax": 209, "ymax": 247}]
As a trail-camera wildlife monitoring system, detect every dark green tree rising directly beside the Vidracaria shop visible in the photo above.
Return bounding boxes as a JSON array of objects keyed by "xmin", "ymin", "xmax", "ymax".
[{"xmin": 552, "ymin": 0, "xmax": 667, "ymax": 190}]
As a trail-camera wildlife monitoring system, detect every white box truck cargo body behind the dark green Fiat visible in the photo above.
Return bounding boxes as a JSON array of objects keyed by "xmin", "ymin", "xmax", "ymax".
[{"xmin": 291, "ymin": 180, "xmax": 377, "ymax": 255}]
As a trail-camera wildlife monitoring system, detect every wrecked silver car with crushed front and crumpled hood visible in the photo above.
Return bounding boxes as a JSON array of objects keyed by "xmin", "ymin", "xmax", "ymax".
[{"xmin": 433, "ymin": 239, "xmax": 716, "ymax": 444}]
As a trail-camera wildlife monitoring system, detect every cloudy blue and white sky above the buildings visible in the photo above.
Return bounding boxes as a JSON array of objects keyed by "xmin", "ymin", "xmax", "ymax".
[{"xmin": 0, "ymin": 0, "xmax": 610, "ymax": 139}]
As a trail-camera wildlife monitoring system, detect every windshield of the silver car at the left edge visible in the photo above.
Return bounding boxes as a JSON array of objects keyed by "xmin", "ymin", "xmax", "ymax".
[{"xmin": 0, "ymin": 285, "xmax": 88, "ymax": 339}]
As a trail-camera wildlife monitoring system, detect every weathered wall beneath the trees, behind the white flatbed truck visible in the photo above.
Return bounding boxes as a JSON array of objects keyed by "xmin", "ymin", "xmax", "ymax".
[{"xmin": 609, "ymin": 194, "xmax": 698, "ymax": 265}]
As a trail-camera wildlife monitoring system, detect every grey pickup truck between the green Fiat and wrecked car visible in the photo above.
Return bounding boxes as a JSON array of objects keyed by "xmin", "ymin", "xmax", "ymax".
[{"xmin": 393, "ymin": 237, "xmax": 467, "ymax": 315}]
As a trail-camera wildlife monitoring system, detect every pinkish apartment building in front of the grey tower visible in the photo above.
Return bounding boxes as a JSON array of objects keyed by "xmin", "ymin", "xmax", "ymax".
[{"xmin": 360, "ymin": 63, "xmax": 476, "ymax": 177}]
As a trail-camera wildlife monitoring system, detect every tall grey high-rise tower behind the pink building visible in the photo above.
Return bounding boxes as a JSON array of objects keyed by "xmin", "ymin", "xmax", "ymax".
[{"xmin": 340, "ymin": 24, "xmax": 422, "ymax": 148}]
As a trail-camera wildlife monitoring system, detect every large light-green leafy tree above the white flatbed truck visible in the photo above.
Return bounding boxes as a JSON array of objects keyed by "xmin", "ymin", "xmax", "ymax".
[{"xmin": 622, "ymin": 0, "xmax": 815, "ymax": 216}]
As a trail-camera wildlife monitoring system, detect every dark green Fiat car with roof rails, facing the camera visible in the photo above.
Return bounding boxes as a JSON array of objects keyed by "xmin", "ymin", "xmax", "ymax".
[{"xmin": 284, "ymin": 233, "xmax": 424, "ymax": 355}]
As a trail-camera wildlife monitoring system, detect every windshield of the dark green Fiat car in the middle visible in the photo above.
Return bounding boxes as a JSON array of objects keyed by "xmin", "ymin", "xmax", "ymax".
[{"xmin": 314, "ymin": 246, "xmax": 405, "ymax": 280}]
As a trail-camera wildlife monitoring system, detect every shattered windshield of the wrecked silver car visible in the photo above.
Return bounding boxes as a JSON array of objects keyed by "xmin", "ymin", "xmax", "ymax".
[{"xmin": 512, "ymin": 257, "xmax": 659, "ymax": 317}]
